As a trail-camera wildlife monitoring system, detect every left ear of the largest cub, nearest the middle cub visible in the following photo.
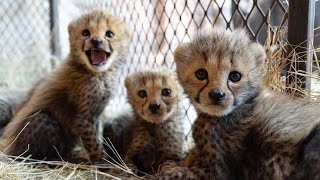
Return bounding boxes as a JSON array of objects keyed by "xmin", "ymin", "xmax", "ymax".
[{"xmin": 173, "ymin": 43, "xmax": 191, "ymax": 64}]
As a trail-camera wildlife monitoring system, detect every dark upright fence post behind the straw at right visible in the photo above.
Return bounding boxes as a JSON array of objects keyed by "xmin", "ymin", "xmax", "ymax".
[{"xmin": 288, "ymin": 0, "xmax": 315, "ymax": 91}]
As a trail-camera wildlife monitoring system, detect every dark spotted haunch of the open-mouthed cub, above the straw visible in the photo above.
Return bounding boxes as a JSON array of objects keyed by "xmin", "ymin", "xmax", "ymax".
[{"xmin": 10, "ymin": 112, "xmax": 74, "ymax": 160}]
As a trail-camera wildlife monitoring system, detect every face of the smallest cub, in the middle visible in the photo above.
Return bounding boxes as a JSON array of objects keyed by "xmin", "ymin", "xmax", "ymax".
[{"xmin": 125, "ymin": 70, "xmax": 181, "ymax": 123}]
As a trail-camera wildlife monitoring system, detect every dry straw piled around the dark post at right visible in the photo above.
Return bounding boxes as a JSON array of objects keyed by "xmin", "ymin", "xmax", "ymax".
[{"xmin": 264, "ymin": 15, "xmax": 320, "ymax": 100}]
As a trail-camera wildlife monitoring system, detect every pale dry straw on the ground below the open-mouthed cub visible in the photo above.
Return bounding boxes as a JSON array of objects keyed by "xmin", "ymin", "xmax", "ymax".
[{"xmin": 0, "ymin": 140, "xmax": 147, "ymax": 180}]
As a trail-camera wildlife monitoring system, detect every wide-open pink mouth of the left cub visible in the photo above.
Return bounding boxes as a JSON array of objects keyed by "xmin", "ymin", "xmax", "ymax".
[{"xmin": 85, "ymin": 48, "xmax": 111, "ymax": 66}]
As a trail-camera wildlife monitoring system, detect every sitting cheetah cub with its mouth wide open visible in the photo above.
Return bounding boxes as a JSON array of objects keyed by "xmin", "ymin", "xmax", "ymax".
[{"xmin": 2, "ymin": 10, "xmax": 131, "ymax": 162}]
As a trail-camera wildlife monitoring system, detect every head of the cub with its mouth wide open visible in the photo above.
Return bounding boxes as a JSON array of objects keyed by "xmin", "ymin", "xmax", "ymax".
[{"xmin": 68, "ymin": 11, "xmax": 131, "ymax": 72}]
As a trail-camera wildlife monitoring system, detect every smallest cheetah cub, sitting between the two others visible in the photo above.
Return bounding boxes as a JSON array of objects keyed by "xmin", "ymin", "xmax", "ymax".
[{"xmin": 124, "ymin": 69, "xmax": 184, "ymax": 174}]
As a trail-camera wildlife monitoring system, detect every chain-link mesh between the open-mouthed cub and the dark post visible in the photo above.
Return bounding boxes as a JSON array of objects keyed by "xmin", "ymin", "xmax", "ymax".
[{"xmin": 102, "ymin": 0, "xmax": 288, "ymax": 134}]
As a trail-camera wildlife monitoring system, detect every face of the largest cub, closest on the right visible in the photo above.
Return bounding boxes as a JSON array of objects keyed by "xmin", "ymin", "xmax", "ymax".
[{"xmin": 174, "ymin": 30, "xmax": 265, "ymax": 116}]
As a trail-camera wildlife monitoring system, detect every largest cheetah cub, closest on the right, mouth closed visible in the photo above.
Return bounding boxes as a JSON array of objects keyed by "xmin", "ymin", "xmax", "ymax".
[{"xmin": 163, "ymin": 30, "xmax": 320, "ymax": 179}]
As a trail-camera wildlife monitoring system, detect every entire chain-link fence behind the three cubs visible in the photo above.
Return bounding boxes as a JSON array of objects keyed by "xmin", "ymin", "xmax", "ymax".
[{"xmin": 0, "ymin": 0, "xmax": 318, "ymax": 138}]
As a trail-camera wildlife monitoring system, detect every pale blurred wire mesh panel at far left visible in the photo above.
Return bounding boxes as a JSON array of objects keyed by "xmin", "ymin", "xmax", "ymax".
[{"xmin": 0, "ymin": 0, "xmax": 50, "ymax": 87}]
